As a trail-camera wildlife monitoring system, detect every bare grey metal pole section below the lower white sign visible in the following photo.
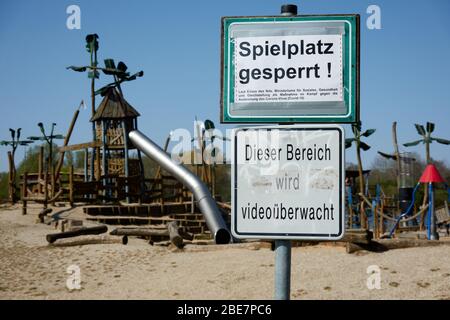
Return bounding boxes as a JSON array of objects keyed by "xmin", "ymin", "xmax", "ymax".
[{"xmin": 275, "ymin": 240, "xmax": 292, "ymax": 300}]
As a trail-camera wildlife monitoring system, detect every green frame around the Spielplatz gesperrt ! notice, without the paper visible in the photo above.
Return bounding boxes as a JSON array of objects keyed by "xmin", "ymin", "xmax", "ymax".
[{"xmin": 220, "ymin": 14, "xmax": 360, "ymax": 124}]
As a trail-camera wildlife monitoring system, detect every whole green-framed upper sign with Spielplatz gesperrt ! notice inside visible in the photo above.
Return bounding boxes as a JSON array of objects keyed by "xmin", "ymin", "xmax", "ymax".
[{"xmin": 220, "ymin": 14, "xmax": 360, "ymax": 123}]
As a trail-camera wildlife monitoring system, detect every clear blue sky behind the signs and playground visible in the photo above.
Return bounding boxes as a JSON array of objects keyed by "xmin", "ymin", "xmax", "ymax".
[{"xmin": 0, "ymin": 0, "xmax": 450, "ymax": 171}]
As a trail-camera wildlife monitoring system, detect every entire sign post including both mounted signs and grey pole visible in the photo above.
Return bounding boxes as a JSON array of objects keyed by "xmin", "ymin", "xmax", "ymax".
[{"xmin": 227, "ymin": 5, "xmax": 359, "ymax": 300}]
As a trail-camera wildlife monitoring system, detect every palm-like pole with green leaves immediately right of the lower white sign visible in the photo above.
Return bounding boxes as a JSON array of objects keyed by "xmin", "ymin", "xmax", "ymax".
[{"xmin": 345, "ymin": 121, "xmax": 375, "ymax": 229}]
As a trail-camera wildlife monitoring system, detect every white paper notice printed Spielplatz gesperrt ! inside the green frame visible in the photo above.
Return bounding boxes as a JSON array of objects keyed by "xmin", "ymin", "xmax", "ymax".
[{"xmin": 234, "ymin": 34, "xmax": 343, "ymax": 103}]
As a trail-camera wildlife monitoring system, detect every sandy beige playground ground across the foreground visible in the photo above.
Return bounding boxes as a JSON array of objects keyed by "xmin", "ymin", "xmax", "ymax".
[{"xmin": 0, "ymin": 202, "xmax": 450, "ymax": 299}]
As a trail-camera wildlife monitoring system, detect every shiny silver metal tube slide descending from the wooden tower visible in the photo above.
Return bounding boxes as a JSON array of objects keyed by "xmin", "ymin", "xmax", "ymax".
[{"xmin": 128, "ymin": 130, "xmax": 231, "ymax": 244}]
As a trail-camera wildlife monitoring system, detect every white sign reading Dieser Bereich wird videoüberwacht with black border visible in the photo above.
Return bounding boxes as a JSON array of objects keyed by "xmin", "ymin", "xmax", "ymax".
[{"xmin": 231, "ymin": 125, "xmax": 345, "ymax": 240}]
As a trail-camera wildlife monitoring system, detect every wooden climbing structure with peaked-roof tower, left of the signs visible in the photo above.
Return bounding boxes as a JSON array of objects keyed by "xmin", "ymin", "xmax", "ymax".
[{"xmin": 2, "ymin": 35, "xmax": 229, "ymax": 245}]
